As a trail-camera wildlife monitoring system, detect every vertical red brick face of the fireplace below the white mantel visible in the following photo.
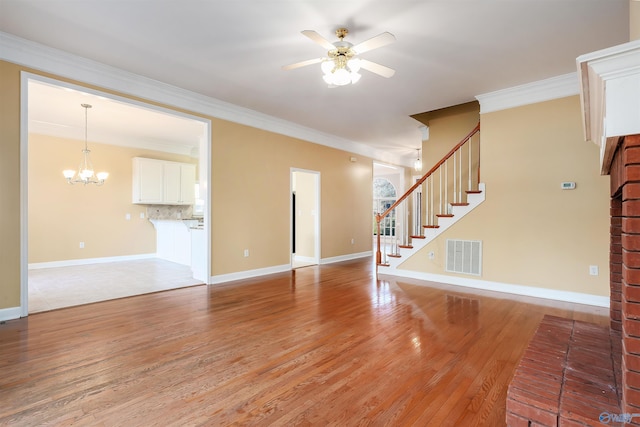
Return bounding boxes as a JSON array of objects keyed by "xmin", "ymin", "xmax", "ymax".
[{"xmin": 610, "ymin": 135, "xmax": 640, "ymax": 425}]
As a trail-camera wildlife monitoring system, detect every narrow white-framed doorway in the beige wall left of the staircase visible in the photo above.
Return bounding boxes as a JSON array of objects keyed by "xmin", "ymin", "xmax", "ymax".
[{"xmin": 290, "ymin": 168, "xmax": 320, "ymax": 268}]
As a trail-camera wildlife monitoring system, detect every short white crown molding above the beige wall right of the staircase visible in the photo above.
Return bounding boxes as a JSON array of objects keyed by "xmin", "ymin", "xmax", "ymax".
[{"xmin": 476, "ymin": 73, "xmax": 580, "ymax": 114}]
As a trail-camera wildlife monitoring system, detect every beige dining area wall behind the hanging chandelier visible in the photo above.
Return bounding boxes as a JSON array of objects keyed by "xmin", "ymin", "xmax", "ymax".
[{"xmin": 28, "ymin": 134, "xmax": 197, "ymax": 263}]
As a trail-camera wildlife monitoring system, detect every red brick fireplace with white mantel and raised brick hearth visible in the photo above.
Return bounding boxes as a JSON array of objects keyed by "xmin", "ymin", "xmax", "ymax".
[{"xmin": 507, "ymin": 40, "xmax": 640, "ymax": 427}]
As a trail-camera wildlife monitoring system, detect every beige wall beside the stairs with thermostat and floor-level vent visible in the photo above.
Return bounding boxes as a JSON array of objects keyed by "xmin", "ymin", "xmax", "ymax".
[{"xmin": 400, "ymin": 96, "xmax": 610, "ymax": 297}]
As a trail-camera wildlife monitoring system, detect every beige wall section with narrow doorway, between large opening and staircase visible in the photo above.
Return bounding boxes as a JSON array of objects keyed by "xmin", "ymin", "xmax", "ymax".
[{"xmin": 211, "ymin": 119, "xmax": 372, "ymax": 275}]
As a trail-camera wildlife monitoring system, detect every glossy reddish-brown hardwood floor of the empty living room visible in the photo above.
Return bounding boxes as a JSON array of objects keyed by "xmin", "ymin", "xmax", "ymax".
[{"xmin": 0, "ymin": 260, "xmax": 608, "ymax": 426}]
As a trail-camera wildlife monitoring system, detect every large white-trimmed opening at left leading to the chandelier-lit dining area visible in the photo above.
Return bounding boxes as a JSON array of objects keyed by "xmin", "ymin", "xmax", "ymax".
[{"xmin": 21, "ymin": 72, "xmax": 211, "ymax": 316}]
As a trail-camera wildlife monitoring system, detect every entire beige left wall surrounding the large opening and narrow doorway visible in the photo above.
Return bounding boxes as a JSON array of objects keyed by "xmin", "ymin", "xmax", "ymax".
[{"xmin": 0, "ymin": 61, "xmax": 372, "ymax": 309}]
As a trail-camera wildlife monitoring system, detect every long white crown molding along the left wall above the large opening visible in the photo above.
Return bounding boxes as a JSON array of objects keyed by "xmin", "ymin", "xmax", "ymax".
[{"xmin": 0, "ymin": 32, "xmax": 410, "ymax": 166}]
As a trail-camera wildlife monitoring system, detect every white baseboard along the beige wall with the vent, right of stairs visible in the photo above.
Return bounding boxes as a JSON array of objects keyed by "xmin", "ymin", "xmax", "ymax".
[{"xmin": 380, "ymin": 269, "xmax": 609, "ymax": 307}]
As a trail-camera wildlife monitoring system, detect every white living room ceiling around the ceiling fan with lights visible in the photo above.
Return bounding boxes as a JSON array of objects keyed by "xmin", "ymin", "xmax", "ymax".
[{"xmin": 0, "ymin": 0, "xmax": 629, "ymax": 164}]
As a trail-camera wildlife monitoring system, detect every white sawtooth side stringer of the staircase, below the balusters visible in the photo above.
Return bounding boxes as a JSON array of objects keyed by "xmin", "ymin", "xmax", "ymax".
[{"xmin": 378, "ymin": 183, "xmax": 486, "ymax": 275}]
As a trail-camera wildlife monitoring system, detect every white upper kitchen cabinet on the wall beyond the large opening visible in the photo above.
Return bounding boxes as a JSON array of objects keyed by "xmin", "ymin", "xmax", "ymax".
[{"xmin": 133, "ymin": 157, "xmax": 196, "ymax": 205}]
